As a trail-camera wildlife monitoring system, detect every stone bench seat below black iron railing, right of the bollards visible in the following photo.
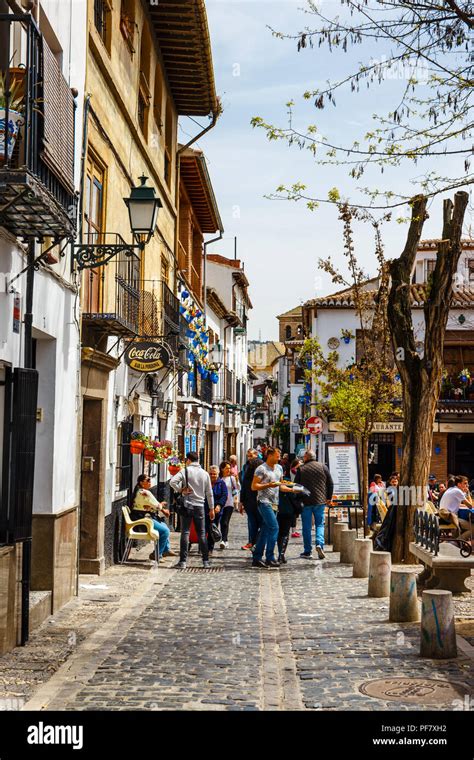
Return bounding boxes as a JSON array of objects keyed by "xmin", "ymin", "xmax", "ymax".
[{"xmin": 410, "ymin": 541, "xmax": 474, "ymax": 594}]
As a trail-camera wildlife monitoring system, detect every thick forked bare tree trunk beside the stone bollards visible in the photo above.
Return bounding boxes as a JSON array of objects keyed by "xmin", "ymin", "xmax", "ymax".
[{"xmin": 388, "ymin": 192, "xmax": 469, "ymax": 562}]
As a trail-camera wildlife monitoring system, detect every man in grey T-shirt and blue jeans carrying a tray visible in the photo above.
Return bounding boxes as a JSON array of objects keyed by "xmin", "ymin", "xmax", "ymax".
[{"xmin": 252, "ymin": 446, "xmax": 291, "ymax": 568}]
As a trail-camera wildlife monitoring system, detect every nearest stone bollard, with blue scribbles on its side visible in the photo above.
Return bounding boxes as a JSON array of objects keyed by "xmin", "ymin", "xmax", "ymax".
[{"xmin": 420, "ymin": 589, "xmax": 458, "ymax": 660}]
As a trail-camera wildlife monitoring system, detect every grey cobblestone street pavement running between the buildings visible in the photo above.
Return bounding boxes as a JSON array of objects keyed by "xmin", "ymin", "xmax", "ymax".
[{"xmin": 0, "ymin": 515, "xmax": 474, "ymax": 711}]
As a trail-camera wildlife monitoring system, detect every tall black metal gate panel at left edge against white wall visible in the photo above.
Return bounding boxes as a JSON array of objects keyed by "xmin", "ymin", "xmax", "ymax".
[{"xmin": 0, "ymin": 368, "xmax": 38, "ymax": 544}]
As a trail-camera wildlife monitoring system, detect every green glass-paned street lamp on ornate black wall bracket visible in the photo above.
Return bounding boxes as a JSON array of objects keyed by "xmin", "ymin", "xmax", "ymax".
[{"xmin": 72, "ymin": 175, "xmax": 163, "ymax": 270}]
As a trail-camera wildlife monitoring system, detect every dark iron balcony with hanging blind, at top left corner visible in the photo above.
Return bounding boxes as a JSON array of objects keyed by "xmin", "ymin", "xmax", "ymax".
[{"xmin": 0, "ymin": 13, "xmax": 76, "ymax": 240}]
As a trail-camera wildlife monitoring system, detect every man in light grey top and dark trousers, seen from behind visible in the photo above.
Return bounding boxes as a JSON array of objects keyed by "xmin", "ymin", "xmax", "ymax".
[{"xmin": 170, "ymin": 451, "xmax": 215, "ymax": 569}]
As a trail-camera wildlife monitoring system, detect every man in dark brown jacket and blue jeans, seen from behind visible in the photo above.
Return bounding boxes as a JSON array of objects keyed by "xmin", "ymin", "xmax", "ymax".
[{"xmin": 295, "ymin": 449, "xmax": 334, "ymax": 559}]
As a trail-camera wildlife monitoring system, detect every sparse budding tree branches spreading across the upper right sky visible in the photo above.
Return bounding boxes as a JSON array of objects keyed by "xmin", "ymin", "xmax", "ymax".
[{"xmin": 252, "ymin": 0, "xmax": 474, "ymax": 209}]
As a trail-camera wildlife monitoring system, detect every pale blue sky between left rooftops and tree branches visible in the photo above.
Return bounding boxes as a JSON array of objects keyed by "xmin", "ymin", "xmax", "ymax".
[{"xmin": 179, "ymin": 0, "xmax": 472, "ymax": 340}]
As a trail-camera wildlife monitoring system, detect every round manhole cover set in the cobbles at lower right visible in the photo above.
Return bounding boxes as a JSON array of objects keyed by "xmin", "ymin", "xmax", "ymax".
[{"xmin": 359, "ymin": 678, "xmax": 469, "ymax": 705}]
